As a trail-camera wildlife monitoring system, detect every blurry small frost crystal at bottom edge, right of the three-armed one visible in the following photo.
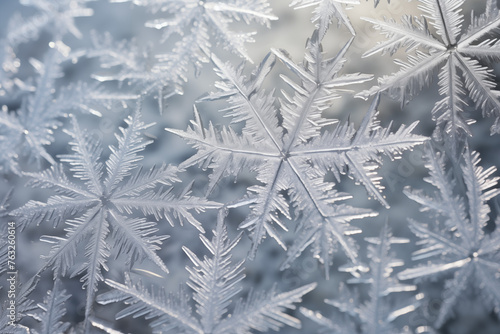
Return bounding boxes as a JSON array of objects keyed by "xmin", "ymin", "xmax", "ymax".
[{"xmin": 301, "ymin": 223, "xmax": 424, "ymax": 334}]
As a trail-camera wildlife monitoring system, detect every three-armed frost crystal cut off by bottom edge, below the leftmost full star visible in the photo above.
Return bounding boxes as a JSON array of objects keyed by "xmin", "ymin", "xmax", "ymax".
[{"xmin": 97, "ymin": 209, "xmax": 316, "ymax": 334}]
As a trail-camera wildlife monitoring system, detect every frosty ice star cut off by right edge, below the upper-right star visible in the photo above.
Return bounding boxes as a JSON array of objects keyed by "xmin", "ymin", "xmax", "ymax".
[{"xmin": 398, "ymin": 147, "xmax": 500, "ymax": 327}]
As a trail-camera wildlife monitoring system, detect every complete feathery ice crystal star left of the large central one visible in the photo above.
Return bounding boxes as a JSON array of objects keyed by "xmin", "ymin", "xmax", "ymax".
[{"xmin": 12, "ymin": 108, "xmax": 218, "ymax": 332}]
